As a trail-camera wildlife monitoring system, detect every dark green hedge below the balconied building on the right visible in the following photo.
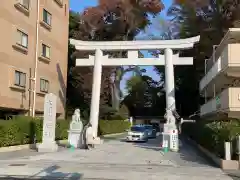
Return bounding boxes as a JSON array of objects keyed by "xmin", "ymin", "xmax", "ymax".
[{"xmin": 182, "ymin": 119, "xmax": 240, "ymax": 159}]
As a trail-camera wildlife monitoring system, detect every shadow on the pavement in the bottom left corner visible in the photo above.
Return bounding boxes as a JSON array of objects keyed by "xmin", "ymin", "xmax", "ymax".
[{"xmin": 0, "ymin": 165, "xmax": 83, "ymax": 180}]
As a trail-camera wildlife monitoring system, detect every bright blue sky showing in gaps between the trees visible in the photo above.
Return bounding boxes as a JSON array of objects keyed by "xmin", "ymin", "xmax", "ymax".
[{"xmin": 70, "ymin": 0, "xmax": 172, "ymax": 93}]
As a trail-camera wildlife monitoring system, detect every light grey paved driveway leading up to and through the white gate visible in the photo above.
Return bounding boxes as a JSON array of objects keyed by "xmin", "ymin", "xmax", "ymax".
[{"xmin": 0, "ymin": 138, "xmax": 236, "ymax": 180}]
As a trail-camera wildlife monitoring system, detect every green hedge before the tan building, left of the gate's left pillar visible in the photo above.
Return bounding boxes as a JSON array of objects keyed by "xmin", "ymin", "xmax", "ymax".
[{"xmin": 0, "ymin": 116, "xmax": 69, "ymax": 147}]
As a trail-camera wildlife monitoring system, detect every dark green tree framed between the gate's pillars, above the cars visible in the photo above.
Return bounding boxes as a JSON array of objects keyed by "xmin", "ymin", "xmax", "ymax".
[{"xmin": 123, "ymin": 75, "xmax": 165, "ymax": 116}]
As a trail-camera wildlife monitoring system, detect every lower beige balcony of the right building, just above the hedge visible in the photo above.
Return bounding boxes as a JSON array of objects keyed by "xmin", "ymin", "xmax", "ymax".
[{"xmin": 200, "ymin": 87, "xmax": 240, "ymax": 118}]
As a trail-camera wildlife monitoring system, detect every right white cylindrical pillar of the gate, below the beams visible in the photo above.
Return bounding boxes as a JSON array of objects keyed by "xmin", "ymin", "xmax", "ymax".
[{"xmin": 164, "ymin": 49, "xmax": 176, "ymax": 110}]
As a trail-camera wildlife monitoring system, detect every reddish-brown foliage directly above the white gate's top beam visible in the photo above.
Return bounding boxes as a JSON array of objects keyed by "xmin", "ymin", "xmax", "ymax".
[{"xmin": 77, "ymin": 0, "xmax": 164, "ymax": 39}]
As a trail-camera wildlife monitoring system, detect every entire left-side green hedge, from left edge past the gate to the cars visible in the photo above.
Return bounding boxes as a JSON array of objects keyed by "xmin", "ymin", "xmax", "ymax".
[{"xmin": 0, "ymin": 116, "xmax": 129, "ymax": 147}]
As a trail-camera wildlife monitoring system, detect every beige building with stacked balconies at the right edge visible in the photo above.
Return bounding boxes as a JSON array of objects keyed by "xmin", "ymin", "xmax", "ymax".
[{"xmin": 199, "ymin": 28, "xmax": 240, "ymax": 120}]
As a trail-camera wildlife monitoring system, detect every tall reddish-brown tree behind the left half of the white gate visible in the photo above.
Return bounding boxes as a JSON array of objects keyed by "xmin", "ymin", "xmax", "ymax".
[{"xmin": 67, "ymin": 0, "xmax": 166, "ymax": 118}]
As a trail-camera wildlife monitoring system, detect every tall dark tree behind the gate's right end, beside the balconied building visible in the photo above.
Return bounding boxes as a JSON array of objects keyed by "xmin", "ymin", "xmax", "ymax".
[{"xmin": 156, "ymin": 0, "xmax": 240, "ymax": 115}]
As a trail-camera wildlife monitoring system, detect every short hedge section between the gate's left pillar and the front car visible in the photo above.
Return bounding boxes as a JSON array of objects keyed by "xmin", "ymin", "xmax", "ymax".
[{"xmin": 98, "ymin": 120, "xmax": 130, "ymax": 135}]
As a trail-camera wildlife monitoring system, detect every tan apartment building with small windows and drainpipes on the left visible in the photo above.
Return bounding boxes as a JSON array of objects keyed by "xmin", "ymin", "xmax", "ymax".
[{"xmin": 0, "ymin": 0, "xmax": 69, "ymax": 118}]
